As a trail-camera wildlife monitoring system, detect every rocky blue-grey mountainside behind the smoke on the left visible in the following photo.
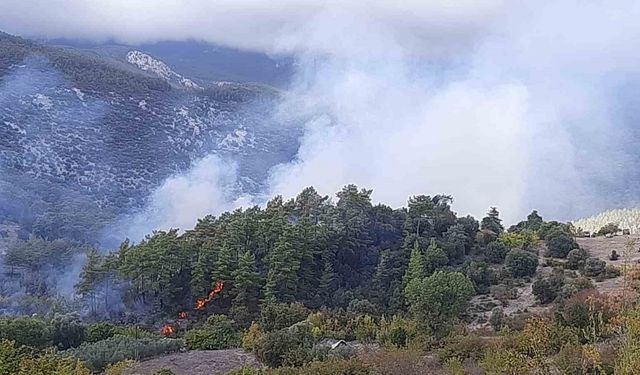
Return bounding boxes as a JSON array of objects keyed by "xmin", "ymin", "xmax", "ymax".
[{"xmin": 0, "ymin": 33, "xmax": 298, "ymax": 244}]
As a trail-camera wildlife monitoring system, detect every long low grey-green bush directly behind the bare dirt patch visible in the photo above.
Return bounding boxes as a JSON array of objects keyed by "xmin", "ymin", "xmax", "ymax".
[{"xmin": 64, "ymin": 335, "xmax": 183, "ymax": 372}]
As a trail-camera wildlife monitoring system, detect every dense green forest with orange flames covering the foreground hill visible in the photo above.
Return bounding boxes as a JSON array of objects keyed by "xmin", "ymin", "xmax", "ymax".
[{"xmin": 0, "ymin": 185, "xmax": 640, "ymax": 375}]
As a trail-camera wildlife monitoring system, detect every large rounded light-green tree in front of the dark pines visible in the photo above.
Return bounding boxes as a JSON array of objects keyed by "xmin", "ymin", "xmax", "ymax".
[{"xmin": 406, "ymin": 271, "xmax": 474, "ymax": 333}]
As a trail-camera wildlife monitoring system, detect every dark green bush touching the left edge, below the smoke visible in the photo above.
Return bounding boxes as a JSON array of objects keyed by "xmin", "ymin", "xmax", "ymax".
[{"xmin": 0, "ymin": 317, "xmax": 53, "ymax": 349}]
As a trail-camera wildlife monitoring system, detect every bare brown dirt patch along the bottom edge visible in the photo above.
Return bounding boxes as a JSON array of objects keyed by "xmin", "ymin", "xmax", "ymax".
[{"xmin": 126, "ymin": 349, "xmax": 261, "ymax": 375}]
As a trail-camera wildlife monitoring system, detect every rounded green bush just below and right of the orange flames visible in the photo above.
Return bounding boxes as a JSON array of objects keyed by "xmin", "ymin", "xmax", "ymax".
[{"xmin": 185, "ymin": 315, "xmax": 240, "ymax": 350}]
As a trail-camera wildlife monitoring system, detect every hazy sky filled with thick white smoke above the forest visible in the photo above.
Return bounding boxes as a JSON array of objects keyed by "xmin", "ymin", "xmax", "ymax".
[{"xmin": 0, "ymin": 0, "xmax": 640, "ymax": 229}]
